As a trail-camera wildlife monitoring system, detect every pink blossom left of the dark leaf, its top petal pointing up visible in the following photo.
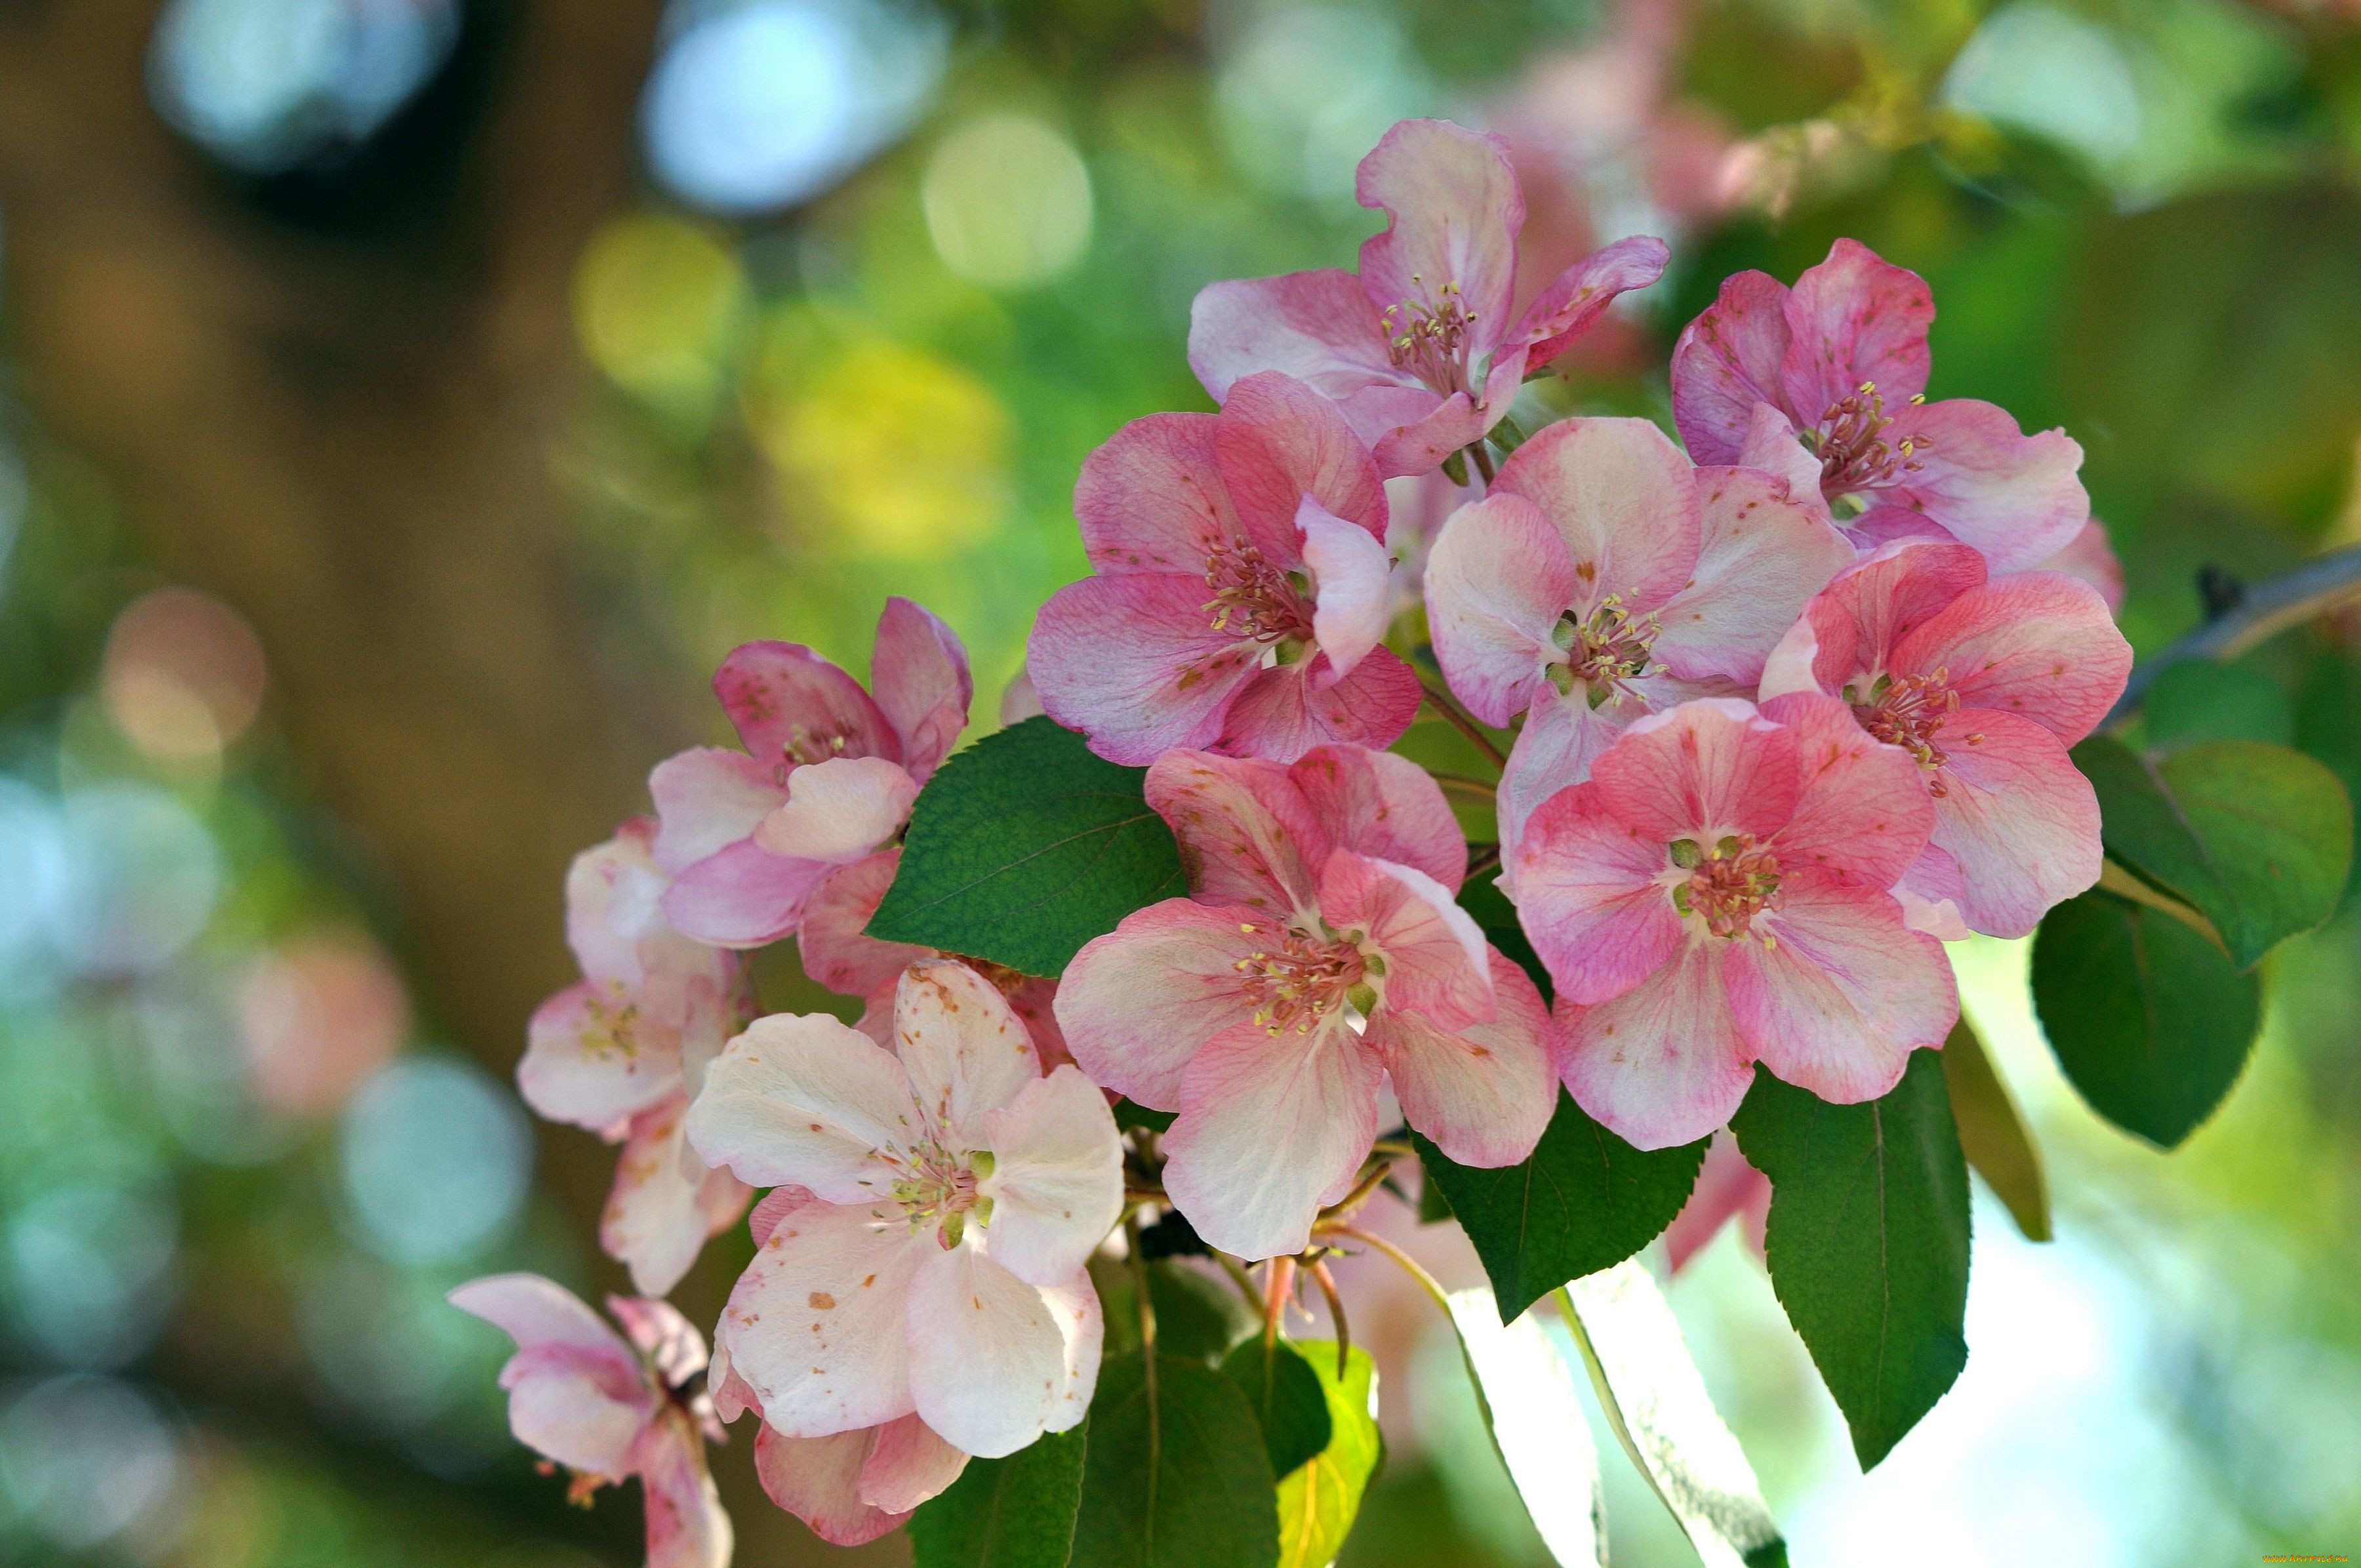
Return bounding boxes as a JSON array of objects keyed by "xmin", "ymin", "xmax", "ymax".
[{"xmin": 647, "ymin": 600, "xmax": 975, "ymax": 947}]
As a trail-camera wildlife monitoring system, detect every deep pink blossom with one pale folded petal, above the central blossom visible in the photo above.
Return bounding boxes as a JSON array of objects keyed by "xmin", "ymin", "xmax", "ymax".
[{"xmin": 1027, "ymin": 376, "xmax": 1419, "ymax": 765}]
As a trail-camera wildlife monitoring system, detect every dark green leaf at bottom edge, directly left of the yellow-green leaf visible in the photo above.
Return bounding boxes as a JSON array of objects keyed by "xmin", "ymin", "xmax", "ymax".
[{"xmin": 1072, "ymin": 1353, "xmax": 1280, "ymax": 1568}]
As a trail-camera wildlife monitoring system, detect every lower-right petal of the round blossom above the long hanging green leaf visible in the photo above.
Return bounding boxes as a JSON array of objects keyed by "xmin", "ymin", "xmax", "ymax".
[{"xmin": 1709, "ymin": 867, "xmax": 1960, "ymax": 1105}]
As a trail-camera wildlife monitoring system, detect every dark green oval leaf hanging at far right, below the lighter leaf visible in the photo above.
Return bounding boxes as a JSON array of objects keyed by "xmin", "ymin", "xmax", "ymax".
[{"xmin": 2033, "ymin": 893, "xmax": 2262, "ymax": 1148}]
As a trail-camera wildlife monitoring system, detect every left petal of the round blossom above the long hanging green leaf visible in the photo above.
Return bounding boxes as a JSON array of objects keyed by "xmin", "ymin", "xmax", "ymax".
[{"xmin": 1516, "ymin": 779, "xmax": 1684, "ymax": 1003}]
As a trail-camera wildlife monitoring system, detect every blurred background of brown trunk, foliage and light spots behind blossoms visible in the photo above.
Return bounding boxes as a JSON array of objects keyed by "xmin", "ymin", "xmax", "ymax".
[{"xmin": 0, "ymin": 0, "xmax": 2361, "ymax": 1568}]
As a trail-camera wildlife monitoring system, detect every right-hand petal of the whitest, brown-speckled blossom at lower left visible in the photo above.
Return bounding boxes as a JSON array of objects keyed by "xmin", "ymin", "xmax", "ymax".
[{"xmin": 977, "ymin": 1065, "xmax": 1124, "ymax": 1285}]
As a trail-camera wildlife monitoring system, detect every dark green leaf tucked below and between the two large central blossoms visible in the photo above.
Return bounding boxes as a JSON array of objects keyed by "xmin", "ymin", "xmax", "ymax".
[{"xmin": 1412, "ymin": 1089, "xmax": 1705, "ymax": 1317}]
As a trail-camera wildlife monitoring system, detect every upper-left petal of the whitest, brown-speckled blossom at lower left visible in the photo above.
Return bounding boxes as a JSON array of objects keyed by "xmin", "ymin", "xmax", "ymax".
[{"xmin": 689, "ymin": 1013, "xmax": 916, "ymax": 1204}]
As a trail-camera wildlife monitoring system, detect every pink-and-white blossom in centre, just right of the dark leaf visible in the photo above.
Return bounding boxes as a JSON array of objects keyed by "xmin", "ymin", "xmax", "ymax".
[{"xmin": 1058, "ymin": 746, "xmax": 1554, "ymax": 1258}]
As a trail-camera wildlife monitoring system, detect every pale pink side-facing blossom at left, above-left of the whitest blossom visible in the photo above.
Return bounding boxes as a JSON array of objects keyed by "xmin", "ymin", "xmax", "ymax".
[{"xmin": 517, "ymin": 817, "xmax": 748, "ymax": 1297}]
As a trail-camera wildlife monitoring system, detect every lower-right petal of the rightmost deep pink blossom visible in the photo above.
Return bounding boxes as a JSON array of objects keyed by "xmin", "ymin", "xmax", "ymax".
[{"xmin": 1933, "ymin": 708, "xmax": 2104, "ymax": 938}]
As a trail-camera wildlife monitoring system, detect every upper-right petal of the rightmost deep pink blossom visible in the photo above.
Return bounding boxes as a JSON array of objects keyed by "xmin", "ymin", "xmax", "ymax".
[{"xmin": 1891, "ymin": 571, "xmax": 2132, "ymax": 746}]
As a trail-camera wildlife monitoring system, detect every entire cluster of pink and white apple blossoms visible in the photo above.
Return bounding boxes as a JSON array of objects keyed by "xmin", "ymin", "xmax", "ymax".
[{"xmin": 456, "ymin": 121, "xmax": 2129, "ymax": 1568}]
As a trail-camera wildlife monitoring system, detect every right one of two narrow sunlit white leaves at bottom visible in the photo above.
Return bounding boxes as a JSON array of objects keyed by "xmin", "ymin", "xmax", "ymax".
[{"xmin": 1558, "ymin": 1258, "xmax": 1787, "ymax": 1568}]
